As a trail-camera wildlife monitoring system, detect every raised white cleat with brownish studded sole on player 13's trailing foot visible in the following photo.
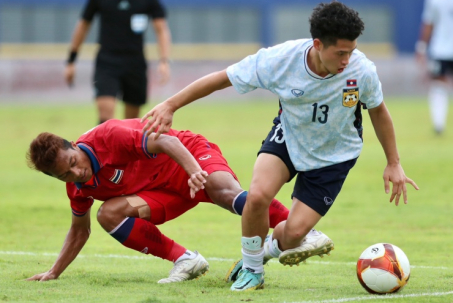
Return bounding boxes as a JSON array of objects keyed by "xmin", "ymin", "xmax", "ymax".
[{"xmin": 278, "ymin": 230, "xmax": 334, "ymax": 266}]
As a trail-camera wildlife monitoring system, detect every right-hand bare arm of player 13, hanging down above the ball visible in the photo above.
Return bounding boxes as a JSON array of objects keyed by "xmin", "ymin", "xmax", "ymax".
[{"xmin": 368, "ymin": 102, "xmax": 418, "ymax": 205}]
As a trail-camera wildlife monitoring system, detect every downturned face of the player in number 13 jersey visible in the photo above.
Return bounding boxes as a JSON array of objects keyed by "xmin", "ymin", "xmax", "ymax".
[{"xmin": 319, "ymin": 39, "xmax": 357, "ymax": 74}]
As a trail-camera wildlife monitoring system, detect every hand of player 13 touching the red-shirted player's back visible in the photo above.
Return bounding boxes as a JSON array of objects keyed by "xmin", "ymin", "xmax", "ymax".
[{"xmin": 141, "ymin": 100, "xmax": 175, "ymax": 140}]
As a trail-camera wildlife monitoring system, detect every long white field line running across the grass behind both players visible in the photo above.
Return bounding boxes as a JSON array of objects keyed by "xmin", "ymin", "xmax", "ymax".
[{"xmin": 0, "ymin": 250, "xmax": 452, "ymax": 270}]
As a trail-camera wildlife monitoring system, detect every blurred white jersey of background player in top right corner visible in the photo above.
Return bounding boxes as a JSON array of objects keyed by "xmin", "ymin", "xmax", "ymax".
[{"xmin": 422, "ymin": 0, "xmax": 453, "ymax": 60}]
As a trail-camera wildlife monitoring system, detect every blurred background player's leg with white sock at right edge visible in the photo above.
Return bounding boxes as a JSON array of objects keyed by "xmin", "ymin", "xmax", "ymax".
[{"xmin": 428, "ymin": 60, "xmax": 449, "ymax": 134}]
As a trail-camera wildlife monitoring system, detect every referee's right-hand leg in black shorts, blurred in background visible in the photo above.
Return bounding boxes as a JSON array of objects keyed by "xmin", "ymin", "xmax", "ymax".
[{"xmin": 121, "ymin": 56, "xmax": 148, "ymax": 119}]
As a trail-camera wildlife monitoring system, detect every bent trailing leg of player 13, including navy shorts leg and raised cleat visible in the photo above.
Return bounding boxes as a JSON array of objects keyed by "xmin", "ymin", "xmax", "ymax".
[{"xmin": 274, "ymin": 159, "xmax": 356, "ymax": 265}]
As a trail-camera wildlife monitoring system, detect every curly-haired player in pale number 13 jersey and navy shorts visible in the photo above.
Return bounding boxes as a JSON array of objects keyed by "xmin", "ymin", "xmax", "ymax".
[{"xmin": 143, "ymin": 2, "xmax": 418, "ymax": 291}]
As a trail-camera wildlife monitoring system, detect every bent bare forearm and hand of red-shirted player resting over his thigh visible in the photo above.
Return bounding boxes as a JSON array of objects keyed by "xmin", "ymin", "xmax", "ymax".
[{"xmin": 146, "ymin": 133, "xmax": 208, "ymax": 198}]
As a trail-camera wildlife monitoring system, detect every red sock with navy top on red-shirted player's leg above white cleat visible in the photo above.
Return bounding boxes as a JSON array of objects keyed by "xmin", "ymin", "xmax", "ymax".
[{"xmin": 109, "ymin": 217, "xmax": 186, "ymax": 262}]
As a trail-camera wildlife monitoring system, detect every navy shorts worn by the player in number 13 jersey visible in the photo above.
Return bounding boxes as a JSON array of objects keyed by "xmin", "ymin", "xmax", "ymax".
[{"xmin": 258, "ymin": 117, "xmax": 357, "ymax": 216}]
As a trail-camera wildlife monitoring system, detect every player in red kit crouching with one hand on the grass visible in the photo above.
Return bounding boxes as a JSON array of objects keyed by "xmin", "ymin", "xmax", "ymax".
[{"xmin": 27, "ymin": 119, "xmax": 288, "ymax": 283}]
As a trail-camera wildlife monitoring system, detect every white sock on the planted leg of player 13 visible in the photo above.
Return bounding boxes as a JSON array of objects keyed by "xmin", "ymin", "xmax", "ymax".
[{"xmin": 241, "ymin": 236, "xmax": 264, "ymax": 273}]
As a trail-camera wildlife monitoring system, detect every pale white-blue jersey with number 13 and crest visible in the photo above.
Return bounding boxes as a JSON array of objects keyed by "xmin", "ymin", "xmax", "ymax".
[{"xmin": 227, "ymin": 39, "xmax": 383, "ymax": 171}]
